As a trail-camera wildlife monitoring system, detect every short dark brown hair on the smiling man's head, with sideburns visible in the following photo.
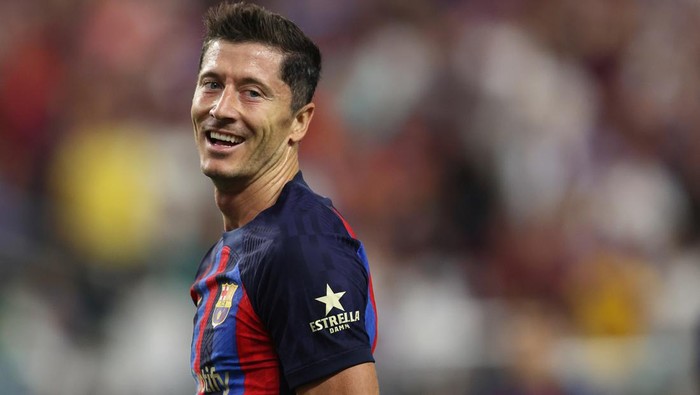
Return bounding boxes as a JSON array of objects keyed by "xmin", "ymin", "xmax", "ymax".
[{"xmin": 199, "ymin": 2, "xmax": 321, "ymax": 111}]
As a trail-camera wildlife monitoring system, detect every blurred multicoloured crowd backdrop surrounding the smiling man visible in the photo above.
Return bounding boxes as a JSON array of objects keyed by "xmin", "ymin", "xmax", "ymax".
[{"xmin": 0, "ymin": 0, "xmax": 700, "ymax": 395}]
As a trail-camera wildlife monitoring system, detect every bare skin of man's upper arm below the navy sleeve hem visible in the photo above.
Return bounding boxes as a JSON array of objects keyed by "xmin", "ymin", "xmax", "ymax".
[{"xmin": 297, "ymin": 362, "xmax": 379, "ymax": 395}]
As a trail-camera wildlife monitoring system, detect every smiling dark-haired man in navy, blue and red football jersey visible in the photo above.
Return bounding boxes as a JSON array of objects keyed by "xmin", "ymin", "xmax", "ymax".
[{"xmin": 191, "ymin": 3, "xmax": 379, "ymax": 394}]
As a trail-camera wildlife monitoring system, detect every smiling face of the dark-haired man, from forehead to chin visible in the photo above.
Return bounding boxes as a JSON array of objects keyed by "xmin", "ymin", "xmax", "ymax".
[{"xmin": 191, "ymin": 40, "xmax": 294, "ymax": 185}]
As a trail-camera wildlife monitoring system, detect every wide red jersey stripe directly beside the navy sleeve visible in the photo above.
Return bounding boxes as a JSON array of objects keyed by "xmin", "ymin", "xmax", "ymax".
[{"xmin": 236, "ymin": 288, "xmax": 280, "ymax": 395}]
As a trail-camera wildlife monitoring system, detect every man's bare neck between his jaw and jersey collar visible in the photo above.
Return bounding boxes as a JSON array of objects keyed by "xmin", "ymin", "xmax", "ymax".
[{"xmin": 214, "ymin": 158, "xmax": 299, "ymax": 232}]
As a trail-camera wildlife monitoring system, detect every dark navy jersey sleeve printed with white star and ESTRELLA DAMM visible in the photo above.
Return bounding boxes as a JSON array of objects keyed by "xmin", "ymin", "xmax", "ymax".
[{"xmin": 250, "ymin": 235, "xmax": 374, "ymax": 388}]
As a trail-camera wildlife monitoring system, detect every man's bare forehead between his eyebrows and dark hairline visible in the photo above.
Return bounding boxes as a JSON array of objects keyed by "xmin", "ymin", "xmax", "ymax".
[{"xmin": 199, "ymin": 40, "xmax": 284, "ymax": 83}]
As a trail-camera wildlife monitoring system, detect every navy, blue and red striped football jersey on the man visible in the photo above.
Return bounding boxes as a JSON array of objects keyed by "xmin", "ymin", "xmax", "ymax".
[{"xmin": 190, "ymin": 173, "xmax": 377, "ymax": 395}]
